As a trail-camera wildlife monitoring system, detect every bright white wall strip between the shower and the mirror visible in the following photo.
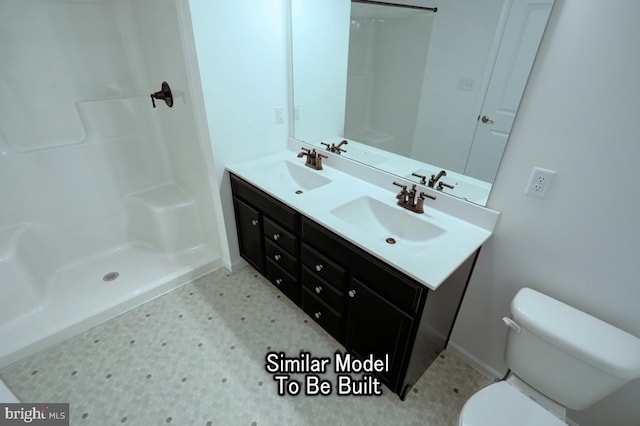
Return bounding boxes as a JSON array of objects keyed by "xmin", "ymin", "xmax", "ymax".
[{"xmin": 189, "ymin": 0, "xmax": 288, "ymax": 267}]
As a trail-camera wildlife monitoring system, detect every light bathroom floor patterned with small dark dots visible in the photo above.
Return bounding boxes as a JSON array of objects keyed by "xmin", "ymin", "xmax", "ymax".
[{"xmin": 0, "ymin": 268, "xmax": 489, "ymax": 426}]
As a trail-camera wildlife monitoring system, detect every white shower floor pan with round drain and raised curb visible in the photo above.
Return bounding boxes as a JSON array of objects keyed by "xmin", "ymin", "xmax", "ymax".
[{"xmin": 0, "ymin": 245, "xmax": 221, "ymax": 368}]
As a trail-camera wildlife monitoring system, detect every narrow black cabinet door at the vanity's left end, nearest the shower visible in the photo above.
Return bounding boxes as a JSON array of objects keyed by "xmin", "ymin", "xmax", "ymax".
[{"xmin": 233, "ymin": 197, "xmax": 264, "ymax": 273}]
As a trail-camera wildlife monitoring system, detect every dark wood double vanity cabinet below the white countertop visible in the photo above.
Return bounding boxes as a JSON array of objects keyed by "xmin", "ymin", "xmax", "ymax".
[{"xmin": 231, "ymin": 174, "xmax": 477, "ymax": 399}]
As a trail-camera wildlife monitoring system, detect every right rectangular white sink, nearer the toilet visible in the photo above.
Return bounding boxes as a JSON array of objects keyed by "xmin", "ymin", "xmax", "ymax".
[{"xmin": 331, "ymin": 196, "xmax": 445, "ymax": 244}]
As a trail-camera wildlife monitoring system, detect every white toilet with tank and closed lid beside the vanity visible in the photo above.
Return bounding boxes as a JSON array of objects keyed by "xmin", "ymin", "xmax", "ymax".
[{"xmin": 459, "ymin": 288, "xmax": 640, "ymax": 426}]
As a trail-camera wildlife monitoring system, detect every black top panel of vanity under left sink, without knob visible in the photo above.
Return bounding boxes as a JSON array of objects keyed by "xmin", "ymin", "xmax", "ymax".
[{"xmin": 229, "ymin": 173, "xmax": 300, "ymax": 232}]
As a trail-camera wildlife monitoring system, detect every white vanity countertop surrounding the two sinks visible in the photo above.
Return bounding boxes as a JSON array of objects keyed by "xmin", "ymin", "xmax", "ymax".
[{"xmin": 227, "ymin": 151, "xmax": 499, "ymax": 290}]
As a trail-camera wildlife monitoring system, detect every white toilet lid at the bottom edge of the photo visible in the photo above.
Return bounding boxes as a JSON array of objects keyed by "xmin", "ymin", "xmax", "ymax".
[{"xmin": 460, "ymin": 382, "xmax": 567, "ymax": 426}]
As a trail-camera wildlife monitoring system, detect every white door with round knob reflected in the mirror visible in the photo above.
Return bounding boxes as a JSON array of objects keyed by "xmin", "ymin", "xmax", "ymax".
[{"xmin": 464, "ymin": 0, "xmax": 553, "ymax": 182}]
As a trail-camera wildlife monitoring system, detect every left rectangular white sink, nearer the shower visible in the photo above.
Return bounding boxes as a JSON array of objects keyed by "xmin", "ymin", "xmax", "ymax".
[{"xmin": 256, "ymin": 161, "xmax": 331, "ymax": 193}]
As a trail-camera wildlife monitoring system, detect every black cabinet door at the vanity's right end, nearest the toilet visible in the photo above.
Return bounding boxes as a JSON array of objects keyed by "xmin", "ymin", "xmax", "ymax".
[{"xmin": 345, "ymin": 278, "xmax": 413, "ymax": 392}]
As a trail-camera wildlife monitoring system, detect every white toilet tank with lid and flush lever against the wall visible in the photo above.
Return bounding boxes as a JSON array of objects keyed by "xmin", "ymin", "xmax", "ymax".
[{"xmin": 505, "ymin": 288, "xmax": 640, "ymax": 410}]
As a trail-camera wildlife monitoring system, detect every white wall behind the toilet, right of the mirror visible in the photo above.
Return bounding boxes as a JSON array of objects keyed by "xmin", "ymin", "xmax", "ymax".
[{"xmin": 452, "ymin": 0, "xmax": 640, "ymax": 426}]
